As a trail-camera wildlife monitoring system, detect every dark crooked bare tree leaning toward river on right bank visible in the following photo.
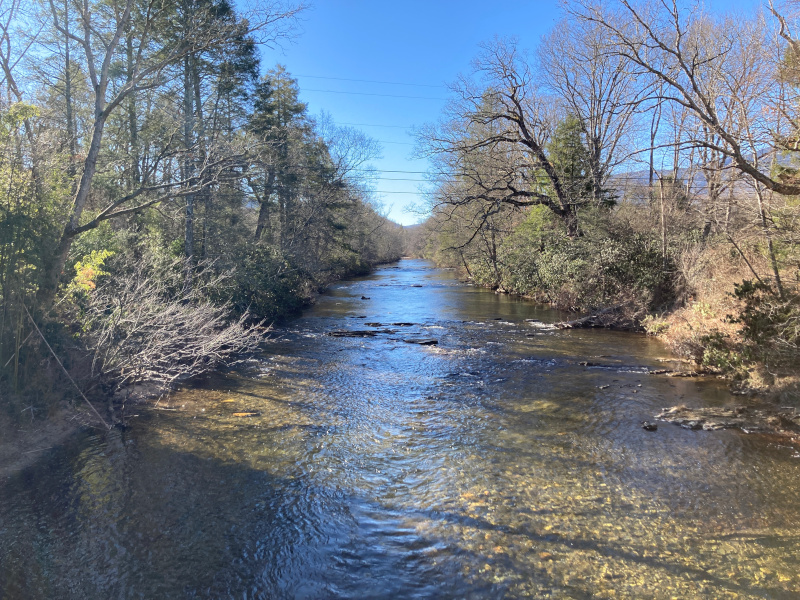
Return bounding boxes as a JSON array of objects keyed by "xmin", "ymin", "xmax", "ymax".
[{"xmin": 418, "ymin": 40, "xmax": 580, "ymax": 235}]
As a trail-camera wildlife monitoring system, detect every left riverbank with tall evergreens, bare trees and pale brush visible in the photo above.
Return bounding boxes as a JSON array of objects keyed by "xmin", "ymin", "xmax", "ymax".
[{"xmin": 0, "ymin": 0, "xmax": 402, "ymax": 432}]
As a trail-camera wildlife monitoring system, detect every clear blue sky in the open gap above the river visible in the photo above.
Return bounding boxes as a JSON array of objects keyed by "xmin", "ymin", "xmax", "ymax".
[{"xmin": 263, "ymin": 0, "xmax": 757, "ymax": 225}]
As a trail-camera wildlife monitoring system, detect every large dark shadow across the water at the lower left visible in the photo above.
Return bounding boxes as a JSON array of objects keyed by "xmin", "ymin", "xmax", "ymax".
[{"xmin": 0, "ymin": 418, "xmax": 496, "ymax": 598}]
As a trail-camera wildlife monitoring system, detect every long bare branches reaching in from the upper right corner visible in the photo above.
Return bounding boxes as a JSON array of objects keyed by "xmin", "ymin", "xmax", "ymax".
[{"xmin": 570, "ymin": 0, "xmax": 800, "ymax": 195}]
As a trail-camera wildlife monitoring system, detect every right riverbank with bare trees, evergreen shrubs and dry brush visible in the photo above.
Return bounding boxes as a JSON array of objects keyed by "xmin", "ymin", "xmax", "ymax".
[{"xmin": 415, "ymin": 0, "xmax": 800, "ymax": 397}]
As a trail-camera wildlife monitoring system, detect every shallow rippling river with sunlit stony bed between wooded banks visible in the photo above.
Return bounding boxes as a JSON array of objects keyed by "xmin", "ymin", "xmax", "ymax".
[{"xmin": 0, "ymin": 261, "xmax": 800, "ymax": 598}]
